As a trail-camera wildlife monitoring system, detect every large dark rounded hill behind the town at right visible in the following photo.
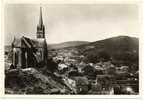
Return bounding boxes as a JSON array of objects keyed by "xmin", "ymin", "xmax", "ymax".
[{"xmin": 73, "ymin": 36, "xmax": 139, "ymax": 65}]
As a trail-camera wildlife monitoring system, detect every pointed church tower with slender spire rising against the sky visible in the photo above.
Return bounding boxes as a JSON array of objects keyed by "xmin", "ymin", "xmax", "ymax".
[{"xmin": 37, "ymin": 7, "xmax": 45, "ymax": 38}]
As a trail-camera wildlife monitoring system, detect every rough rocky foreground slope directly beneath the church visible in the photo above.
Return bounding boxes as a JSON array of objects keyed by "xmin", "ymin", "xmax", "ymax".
[{"xmin": 5, "ymin": 68, "xmax": 71, "ymax": 94}]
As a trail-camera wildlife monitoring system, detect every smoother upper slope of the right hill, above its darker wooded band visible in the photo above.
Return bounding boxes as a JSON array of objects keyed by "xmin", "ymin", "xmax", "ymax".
[{"xmin": 77, "ymin": 36, "xmax": 139, "ymax": 53}]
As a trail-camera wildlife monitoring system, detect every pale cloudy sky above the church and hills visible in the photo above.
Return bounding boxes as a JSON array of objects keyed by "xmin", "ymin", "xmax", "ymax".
[{"xmin": 4, "ymin": 4, "xmax": 139, "ymax": 45}]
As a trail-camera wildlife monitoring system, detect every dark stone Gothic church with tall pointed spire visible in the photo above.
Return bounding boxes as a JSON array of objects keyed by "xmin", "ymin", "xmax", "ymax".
[{"xmin": 12, "ymin": 7, "xmax": 48, "ymax": 68}]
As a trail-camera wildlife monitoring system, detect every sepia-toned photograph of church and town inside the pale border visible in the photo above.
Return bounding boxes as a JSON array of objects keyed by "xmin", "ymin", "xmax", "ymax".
[{"xmin": 4, "ymin": 3, "xmax": 140, "ymax": 95}]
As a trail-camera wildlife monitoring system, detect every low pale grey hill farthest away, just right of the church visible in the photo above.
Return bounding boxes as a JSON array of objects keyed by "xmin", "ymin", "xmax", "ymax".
[{"xmin": 48, "ymin": 41, "xmax": 90, "ymax": 49}]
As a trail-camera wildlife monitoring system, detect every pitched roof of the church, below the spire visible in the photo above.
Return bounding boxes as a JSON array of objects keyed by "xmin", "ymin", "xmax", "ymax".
[{"xmin": 12, "ymin": 36, "xmax": 47, "ymax": 48}]
